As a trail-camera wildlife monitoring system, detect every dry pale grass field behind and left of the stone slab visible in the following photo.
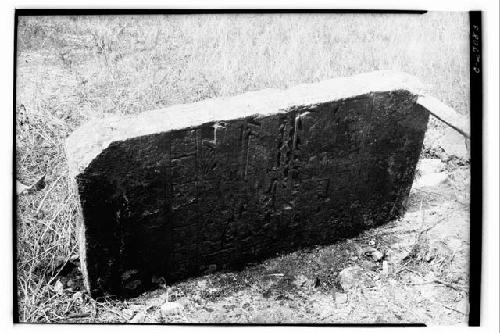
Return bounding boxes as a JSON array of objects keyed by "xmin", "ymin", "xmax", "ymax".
[{"xmin": 16, "ymin": 13, "xmax": 469, "ymax": 322}]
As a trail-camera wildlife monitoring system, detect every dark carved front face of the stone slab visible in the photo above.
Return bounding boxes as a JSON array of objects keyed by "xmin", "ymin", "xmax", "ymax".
[{"xmin": 77, "ymin": 91, "xmax": 429, "ymax": 297}]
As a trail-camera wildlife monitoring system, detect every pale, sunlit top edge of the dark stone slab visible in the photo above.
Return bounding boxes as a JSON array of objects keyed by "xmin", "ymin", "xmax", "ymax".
[{"xmin": 66, "ymin": 71, "xmax": 423, "ymax": 177}]
